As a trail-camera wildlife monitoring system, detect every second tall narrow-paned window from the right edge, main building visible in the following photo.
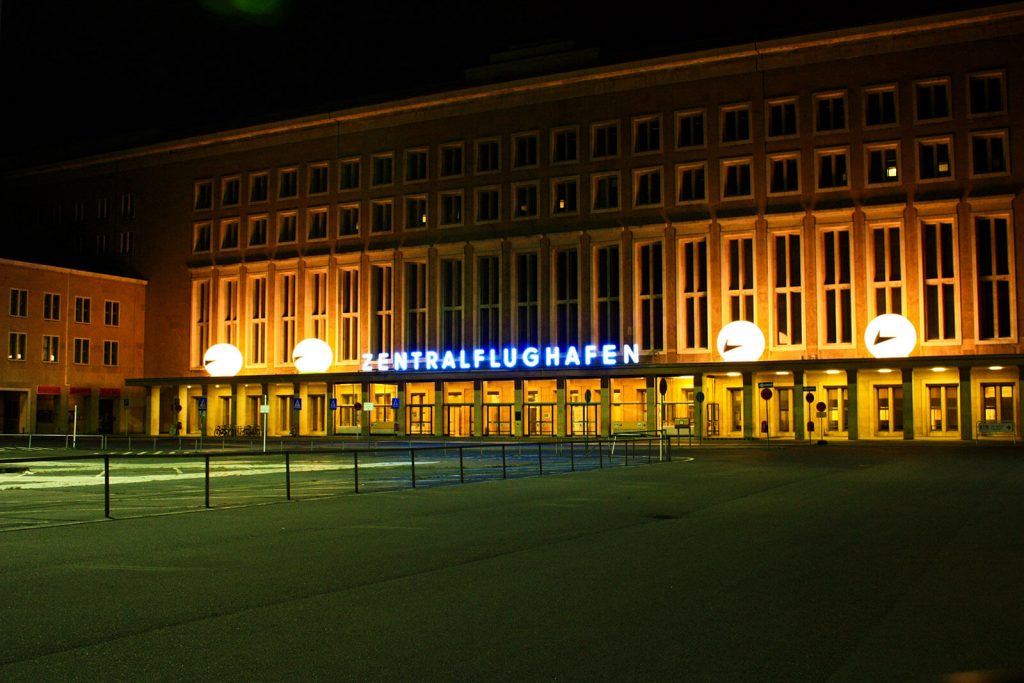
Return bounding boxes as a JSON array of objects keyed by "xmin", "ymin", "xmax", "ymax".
[{"xmin": 921, "ymin": 221, "xmax": 958, "ymax": 341}]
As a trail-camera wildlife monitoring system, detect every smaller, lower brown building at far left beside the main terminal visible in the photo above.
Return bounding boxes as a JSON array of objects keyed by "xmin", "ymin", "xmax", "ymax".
[{"xmin": 0, "ymin": 259, "xmax": 146, "ymax": 434}]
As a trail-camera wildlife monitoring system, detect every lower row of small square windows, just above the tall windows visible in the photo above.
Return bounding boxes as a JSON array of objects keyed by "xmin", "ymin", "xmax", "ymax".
[{"xmin": 193, "ymin": 131, "xmax": 1009, "ymax": 253}]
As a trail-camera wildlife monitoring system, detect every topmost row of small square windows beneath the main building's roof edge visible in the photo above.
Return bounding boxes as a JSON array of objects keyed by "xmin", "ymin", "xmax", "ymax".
[{"xmin": 192, "ymin": 71, "xmax": 1006, "ymax": 210}]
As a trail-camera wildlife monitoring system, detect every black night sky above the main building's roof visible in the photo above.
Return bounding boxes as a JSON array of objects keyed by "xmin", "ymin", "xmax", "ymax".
[{"xmin": 0, "ymin": 0, "xmax": 999, "ymax": 167}]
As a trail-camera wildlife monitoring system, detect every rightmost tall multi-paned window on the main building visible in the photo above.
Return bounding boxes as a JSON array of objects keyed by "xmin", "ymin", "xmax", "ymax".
[{"xmin": 974, "ymin": 216, "xmax": 1016, "ymax": 340}]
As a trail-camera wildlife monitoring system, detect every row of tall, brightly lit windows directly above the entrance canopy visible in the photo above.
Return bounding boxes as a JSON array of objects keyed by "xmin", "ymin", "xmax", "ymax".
[{"xmin": 191, "ymin": 215, "xmax": 1018, "ymax": 366}]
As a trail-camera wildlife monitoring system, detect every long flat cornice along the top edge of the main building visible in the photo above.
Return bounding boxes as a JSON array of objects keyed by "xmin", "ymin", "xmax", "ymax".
[{"xmin": 8, "ymin": 2, "xmax": 1024, "ymax": 177}]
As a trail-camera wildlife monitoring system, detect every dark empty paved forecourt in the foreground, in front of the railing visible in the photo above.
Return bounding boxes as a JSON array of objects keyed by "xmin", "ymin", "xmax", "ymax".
[{"xmin": 0, "ymin": 443, "xmax": 1024, "ymax": 682}]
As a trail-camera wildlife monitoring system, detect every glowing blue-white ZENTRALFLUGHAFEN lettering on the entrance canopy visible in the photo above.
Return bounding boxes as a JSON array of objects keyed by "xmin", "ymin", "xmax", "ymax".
[{"xmin": 361, "ymin": 344, "xmax": 640, "ymax": 373}]
